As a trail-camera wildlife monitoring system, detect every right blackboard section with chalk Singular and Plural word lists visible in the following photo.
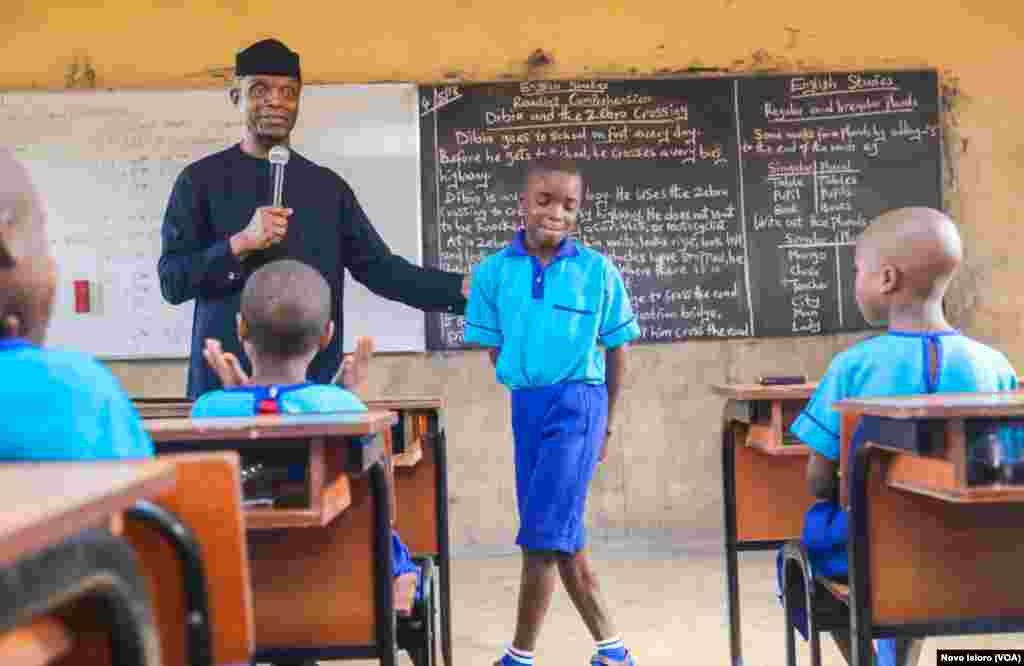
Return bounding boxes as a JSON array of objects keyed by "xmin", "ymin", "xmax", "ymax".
[{"xmin": 737, "ymin": 73, "xmax": 941, "ymax": 335}]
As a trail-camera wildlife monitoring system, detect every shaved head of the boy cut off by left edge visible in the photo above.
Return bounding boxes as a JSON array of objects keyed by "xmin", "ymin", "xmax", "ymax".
[{"xmin": 0, "ymin": 150, "xmax": 56, "ymax": 344}]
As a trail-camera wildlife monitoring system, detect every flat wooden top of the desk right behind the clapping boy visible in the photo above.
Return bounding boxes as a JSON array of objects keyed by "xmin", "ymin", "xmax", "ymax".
[{"xmin": 142, "ymin": 410, "xmax": 398, "ymax": 443}]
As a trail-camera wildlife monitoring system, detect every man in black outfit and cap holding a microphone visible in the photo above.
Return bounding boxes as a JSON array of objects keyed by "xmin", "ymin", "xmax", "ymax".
[{"xmin": 158, "ymin": 39, "xmax": 469, "ymax": 399}]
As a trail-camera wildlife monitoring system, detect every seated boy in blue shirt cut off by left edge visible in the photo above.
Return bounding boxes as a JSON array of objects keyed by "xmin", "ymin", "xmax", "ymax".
[{"xmin": 0, "ymin": 150, "xmax": 153, "ymax": 462}]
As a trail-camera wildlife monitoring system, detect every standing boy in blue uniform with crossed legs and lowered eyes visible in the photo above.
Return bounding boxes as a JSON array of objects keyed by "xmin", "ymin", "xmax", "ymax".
[{"xmin": 465, "ymin": 159, "xmax": 640, "ymax": 666}]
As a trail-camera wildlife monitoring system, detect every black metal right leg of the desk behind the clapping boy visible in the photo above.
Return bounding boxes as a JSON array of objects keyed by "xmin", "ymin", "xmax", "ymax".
[{"xmin": 370, "ymin": 461, "xmax": 398, "ymax": 666}]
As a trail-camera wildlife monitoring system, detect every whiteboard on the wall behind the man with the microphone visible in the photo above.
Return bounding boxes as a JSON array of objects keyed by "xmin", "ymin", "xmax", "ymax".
[{"xmin": 0, "ymin": 84, "xmax": 425, "ymax": 359}]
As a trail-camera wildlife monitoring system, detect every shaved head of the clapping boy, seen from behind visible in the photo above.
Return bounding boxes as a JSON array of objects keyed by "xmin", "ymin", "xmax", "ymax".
[{"xmin": 242, "ymin": 259, "xmax": 331, "ymax": 359}]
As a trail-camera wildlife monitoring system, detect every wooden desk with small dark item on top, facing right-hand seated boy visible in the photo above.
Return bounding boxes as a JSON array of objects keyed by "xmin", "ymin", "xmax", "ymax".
[{"xmin": 712, "ymin": 384, "xmax": 816, "ymax": 666}]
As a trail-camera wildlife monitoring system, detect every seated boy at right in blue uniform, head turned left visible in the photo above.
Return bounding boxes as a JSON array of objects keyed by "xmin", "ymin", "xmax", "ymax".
[{"xmin": 780, "ymin": 208, "xmax": 1017, "ymax": 666}]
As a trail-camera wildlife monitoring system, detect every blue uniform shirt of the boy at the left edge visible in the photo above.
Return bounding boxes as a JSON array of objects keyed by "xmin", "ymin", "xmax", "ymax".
[{"xmin": 0, "ymin": 338, "xmax": 153, "ymax": 462}]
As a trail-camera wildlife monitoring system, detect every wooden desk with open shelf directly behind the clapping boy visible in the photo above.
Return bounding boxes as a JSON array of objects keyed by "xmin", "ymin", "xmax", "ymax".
[{"xmin": 144, "ymin": 411, "xmax": 407, "ymax": 666}]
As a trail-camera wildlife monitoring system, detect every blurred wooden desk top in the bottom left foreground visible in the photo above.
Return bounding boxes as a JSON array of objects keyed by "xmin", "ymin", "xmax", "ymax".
[{"xmin": 0, "ymin": 460, "xmax": 175, "ymax": 566}]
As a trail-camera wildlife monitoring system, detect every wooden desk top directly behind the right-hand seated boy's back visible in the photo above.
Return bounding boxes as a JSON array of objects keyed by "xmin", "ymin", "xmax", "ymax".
[{"xmin": 835, "ymin": 391, "xmax": 1024, "ymax": 419}]
